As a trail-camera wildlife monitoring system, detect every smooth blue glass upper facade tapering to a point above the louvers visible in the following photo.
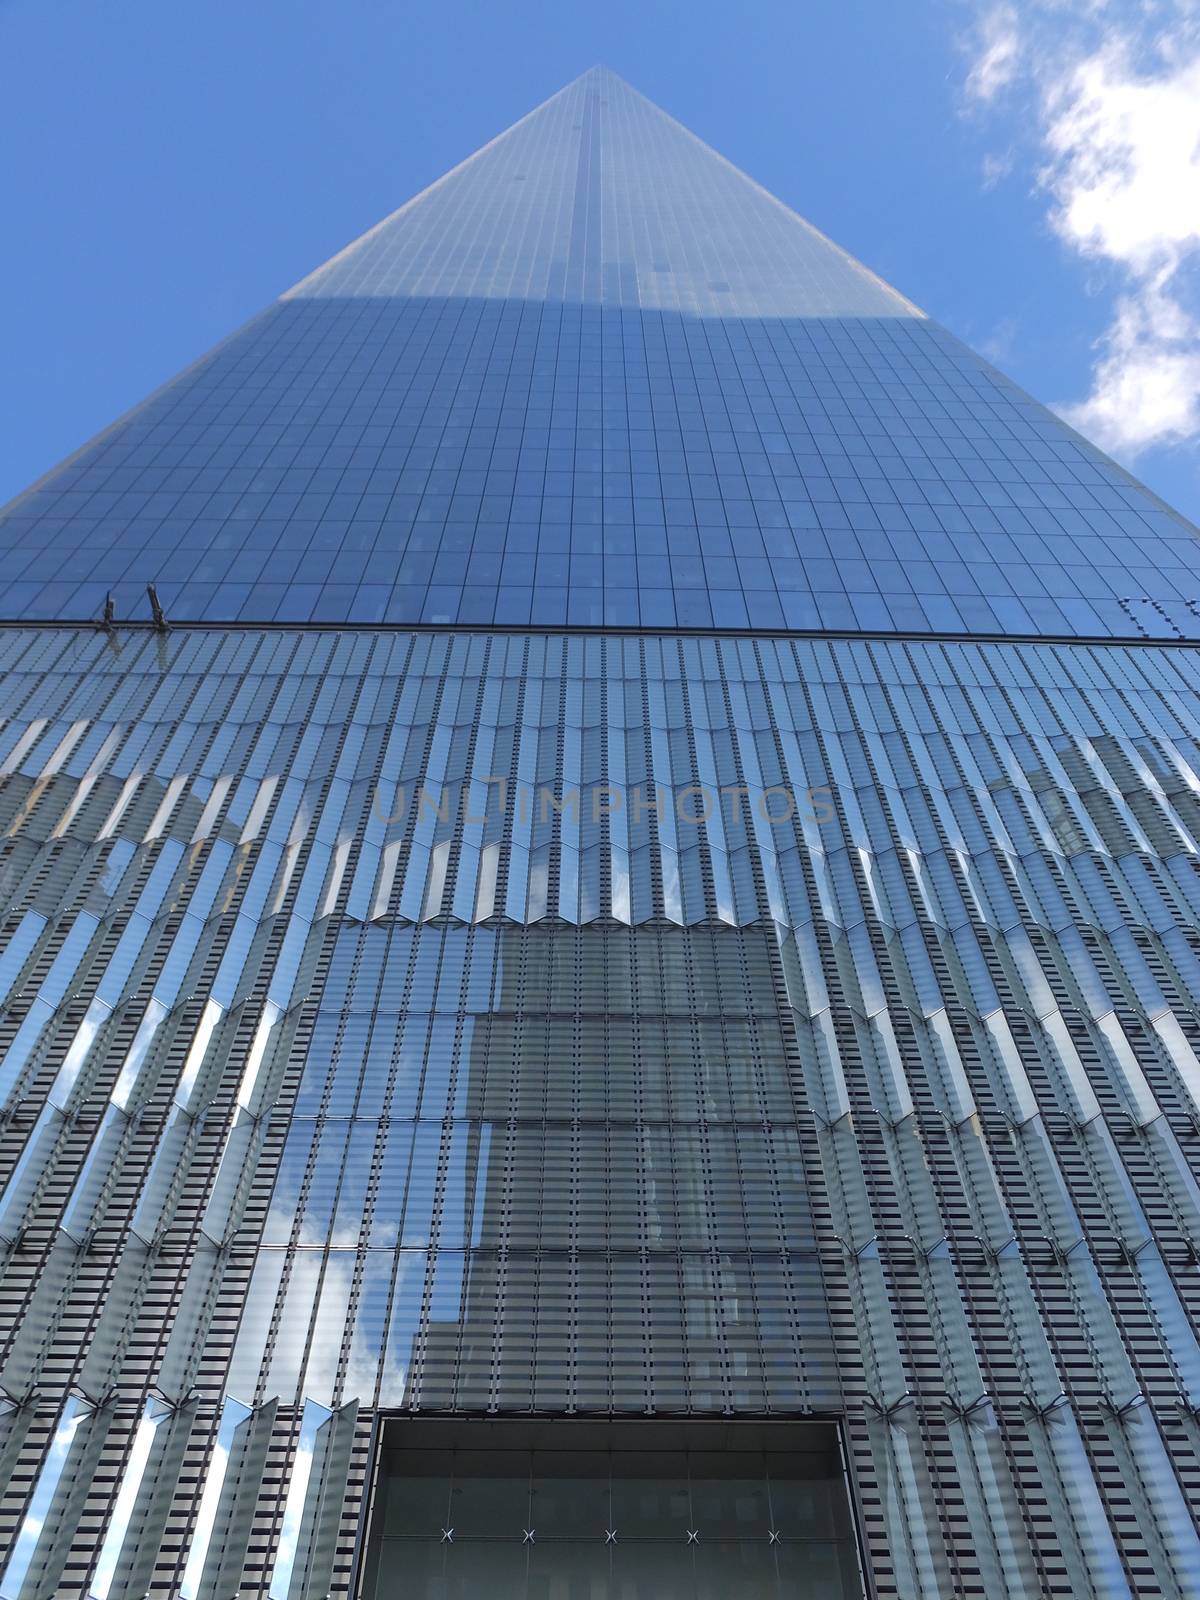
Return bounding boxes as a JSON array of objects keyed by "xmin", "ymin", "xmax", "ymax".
[{"xmin": 0, "ymin": 69, "xmax": 1200, "ymax": 638}]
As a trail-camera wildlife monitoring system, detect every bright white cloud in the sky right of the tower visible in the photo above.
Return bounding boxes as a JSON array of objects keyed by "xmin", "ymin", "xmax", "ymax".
[{"xmin": 965, "ymin": 0, "xmax": 1200, "ymax": 459}]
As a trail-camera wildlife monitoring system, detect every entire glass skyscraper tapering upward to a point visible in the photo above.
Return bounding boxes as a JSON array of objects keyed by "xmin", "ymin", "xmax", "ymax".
[{"xmin": 0, "ymin": 56, "xmax": 1200, "ymax": 1600}]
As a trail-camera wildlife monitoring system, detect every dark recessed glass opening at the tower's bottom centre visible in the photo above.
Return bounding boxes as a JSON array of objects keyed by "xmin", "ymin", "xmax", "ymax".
[{"xmin": 360, "ymin": 1418, "xmax": 862, "ymax": 1600}]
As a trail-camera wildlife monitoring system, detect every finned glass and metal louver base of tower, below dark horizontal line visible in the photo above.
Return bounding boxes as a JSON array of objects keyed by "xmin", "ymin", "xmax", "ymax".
[{"xmin": 0, "ymin": 630, "xmax": 1200, "ymax": 1600}]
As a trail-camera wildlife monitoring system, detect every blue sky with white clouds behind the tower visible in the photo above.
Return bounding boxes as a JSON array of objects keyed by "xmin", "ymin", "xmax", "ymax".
[{"xmin": 0, "ymin": 0, "xmax": 1200, "ymax": 520}]
